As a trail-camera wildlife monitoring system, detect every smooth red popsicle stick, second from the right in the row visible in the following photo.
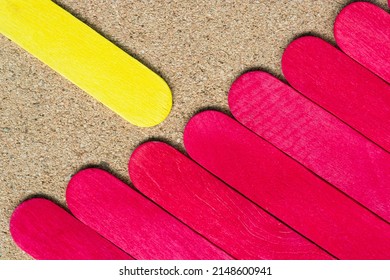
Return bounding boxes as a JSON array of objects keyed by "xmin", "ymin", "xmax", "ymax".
[{"xmin": 282, "ymin": 36, "xmax": 390, "ymax": 151}]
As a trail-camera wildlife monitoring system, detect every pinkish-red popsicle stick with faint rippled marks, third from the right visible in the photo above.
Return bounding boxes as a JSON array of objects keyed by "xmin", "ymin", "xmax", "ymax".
[{"xmin": 229, "ymin": 71, "xmax": 390, "ymax": 222}]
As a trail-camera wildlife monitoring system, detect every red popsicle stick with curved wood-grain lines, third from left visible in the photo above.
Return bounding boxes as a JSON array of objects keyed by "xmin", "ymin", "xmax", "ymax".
[{"xmin": 129, "ymin": 142, "xmax": 331, "ymax": 259}]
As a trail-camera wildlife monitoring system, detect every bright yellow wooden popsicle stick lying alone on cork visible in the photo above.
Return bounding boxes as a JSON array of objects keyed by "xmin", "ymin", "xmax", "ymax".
[{"xmin": 0, "ymin": 0, "xmax": 172, "ymax": 127}]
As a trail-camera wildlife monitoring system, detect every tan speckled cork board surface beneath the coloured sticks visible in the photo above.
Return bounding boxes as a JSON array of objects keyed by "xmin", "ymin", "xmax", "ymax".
[{"xmin": 0, "ymin": 0, "xmax": 387, "ymax": 259}]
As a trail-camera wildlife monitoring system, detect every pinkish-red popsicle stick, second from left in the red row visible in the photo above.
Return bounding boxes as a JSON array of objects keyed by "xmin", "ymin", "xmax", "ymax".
[{"xmin": 66, "ymin": 168, "xmax": 231, "ymax": 260}]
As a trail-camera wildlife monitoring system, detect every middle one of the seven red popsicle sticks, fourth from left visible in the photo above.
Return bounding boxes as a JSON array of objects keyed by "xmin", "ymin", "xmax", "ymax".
[{"xmin": 184, "ymin": 111, "xmax": 390, "ymax": 259}]
